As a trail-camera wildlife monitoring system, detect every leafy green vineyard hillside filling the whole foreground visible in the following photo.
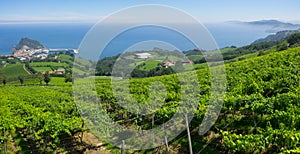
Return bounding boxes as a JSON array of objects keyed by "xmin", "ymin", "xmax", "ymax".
[{"xmin": 0, "ymin": 34, "xmax": 300, "ymax": 153}]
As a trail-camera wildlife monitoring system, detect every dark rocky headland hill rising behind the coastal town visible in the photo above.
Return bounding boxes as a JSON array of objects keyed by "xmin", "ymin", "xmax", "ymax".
[{"xmin": 15, "ymin": 38, "xmax": 45, "ymax": 50}]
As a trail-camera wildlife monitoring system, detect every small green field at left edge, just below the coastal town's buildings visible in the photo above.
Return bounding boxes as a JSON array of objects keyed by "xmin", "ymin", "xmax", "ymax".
[{"xmin": 0, "ymin": 63, "xmax": 29, "ymax": 79}]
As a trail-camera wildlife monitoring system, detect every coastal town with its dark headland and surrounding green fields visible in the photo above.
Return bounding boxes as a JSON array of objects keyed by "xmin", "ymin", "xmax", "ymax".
[{"xmin": 0, "ymin": 38, "xmax": 79, "ymax": 78}]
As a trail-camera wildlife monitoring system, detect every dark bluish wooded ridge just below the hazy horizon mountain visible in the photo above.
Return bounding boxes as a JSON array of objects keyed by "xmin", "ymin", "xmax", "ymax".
[{"xmin": 252, "ymin": 29, "xmax": 300, "ymax": 44}]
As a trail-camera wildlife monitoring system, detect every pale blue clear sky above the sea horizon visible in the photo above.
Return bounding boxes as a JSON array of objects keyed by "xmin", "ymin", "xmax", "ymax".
[{"xmin": 0, "ymin": 0, "xmax": 300, "ymax": 23}]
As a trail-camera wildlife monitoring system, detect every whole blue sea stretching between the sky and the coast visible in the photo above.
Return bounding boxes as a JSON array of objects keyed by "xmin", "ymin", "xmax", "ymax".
[{"xmin": 0, "ymin": 23, "xmax": 270, "ymax": 57}]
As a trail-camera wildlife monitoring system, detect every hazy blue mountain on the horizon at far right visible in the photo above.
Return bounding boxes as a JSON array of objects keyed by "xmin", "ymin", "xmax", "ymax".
[{"xmin": 230, "ymin": 20, "xmax": 300, "ymax": 33}]
